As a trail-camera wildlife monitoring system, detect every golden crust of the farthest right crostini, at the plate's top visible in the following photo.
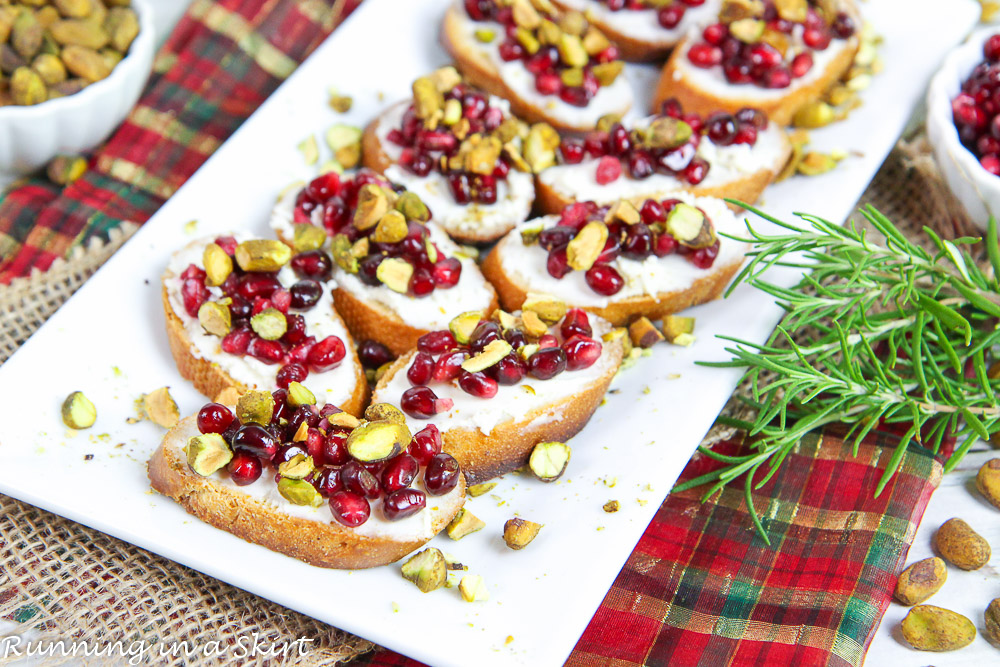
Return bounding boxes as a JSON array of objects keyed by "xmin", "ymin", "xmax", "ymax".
[{"xmin": 653, "ymin": 35, "xmax": 860, "ymax": 125}]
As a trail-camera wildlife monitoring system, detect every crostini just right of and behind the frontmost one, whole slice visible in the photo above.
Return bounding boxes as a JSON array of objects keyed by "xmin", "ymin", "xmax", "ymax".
[{"xmin": 374, "ymin": 306, "xmax": 626, "ymax": 484}]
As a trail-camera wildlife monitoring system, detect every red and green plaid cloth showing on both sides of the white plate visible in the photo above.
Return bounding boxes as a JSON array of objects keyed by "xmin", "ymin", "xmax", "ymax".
[{"xmin": 0, "ymin": 0, "xmax": 941, "ymax": 666}]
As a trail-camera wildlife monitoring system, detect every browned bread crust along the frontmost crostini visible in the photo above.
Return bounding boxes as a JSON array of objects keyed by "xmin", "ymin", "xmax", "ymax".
[{"xmin": 146, "ymin": 417, "xmax": 465, "ymax": 570}]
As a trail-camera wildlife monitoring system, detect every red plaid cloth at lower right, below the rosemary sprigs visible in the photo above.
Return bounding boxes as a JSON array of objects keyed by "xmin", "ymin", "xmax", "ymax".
[{"xmin": 355, "ymin": 432, "xmax": 942, "ymax": 667}]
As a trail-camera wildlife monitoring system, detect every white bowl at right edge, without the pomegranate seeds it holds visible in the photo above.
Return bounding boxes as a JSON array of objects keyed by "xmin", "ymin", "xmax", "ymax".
[{"xmin": 927, "ymin": 26, "xmax": 1000, "ymax": 229}]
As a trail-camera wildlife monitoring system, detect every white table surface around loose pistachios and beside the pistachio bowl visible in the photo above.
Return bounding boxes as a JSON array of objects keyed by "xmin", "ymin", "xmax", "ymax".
[{"xmin": 58, "ymin": 0, "xmax": 1000, "ymax": 667}]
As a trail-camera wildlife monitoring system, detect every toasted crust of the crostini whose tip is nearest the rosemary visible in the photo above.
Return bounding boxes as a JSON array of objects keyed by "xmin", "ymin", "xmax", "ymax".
[{"xmin": 482, "ymin": 245, "xmax": 743, "ymax": 326}]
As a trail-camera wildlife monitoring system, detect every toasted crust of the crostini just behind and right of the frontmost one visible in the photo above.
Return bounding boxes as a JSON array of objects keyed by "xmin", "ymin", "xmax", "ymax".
[{"xmin": 374, "ymin": 341, "xmax": 624, "ymax": 485}]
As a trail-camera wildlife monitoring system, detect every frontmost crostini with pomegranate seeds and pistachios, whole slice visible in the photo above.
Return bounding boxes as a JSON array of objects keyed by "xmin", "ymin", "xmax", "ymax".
[{"xmin": 147, "ymin": 394, "xmax": 465, "ymax": 569}]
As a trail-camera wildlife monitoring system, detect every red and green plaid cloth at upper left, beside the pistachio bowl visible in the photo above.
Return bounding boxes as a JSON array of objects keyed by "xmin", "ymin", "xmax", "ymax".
[{"xmin": 0, "ymin": 0, "xmax": 360, "ymax": 284}]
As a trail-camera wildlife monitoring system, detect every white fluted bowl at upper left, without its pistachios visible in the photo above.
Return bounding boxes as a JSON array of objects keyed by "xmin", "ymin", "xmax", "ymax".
[{"xmin": 0, "ymin": 0, "xmax": 155, "ymax": 176}]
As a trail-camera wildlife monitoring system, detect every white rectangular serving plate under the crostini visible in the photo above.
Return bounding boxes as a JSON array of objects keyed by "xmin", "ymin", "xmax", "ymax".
[{"xmin": 0, "ymin": 0, "xmax": 978, "ymax": 667}]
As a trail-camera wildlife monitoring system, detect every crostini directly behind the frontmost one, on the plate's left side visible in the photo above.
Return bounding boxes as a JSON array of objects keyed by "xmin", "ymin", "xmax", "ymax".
[{"xmin": 162, "ymin": 233, "xmax": 368, "ymax": 414}]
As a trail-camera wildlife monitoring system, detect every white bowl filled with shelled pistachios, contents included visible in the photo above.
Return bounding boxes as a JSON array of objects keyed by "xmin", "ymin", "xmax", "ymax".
[{"xmin": 0, "ymin": 0, "xmax": 154, "ymax": 175}]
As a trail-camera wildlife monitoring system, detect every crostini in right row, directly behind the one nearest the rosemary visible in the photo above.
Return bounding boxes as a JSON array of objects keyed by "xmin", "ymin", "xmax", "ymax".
[{"xmin": 536, "ymin": 101, "xmax": 792, "ymax": 213}]
